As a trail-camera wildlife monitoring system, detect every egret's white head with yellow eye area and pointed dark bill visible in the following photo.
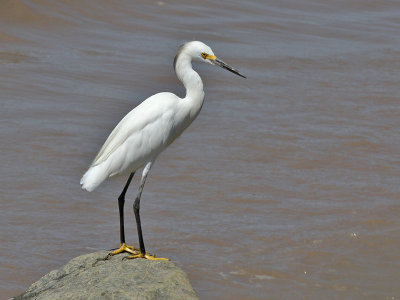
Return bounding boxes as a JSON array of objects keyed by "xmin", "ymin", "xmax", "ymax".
[{"xmin": 174, "ymin": 41, "xmax": 246, "ymax": 78}]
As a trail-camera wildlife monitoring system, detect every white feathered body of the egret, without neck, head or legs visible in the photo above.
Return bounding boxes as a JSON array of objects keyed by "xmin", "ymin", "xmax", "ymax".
[{"xmin": 81, "ymin": 93, "xmax": 192, "ymax": 191}]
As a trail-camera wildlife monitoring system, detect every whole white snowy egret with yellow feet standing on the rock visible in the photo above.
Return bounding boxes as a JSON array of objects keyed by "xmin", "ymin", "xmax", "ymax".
[{"xmin": 81, "ymin": 41, "xmax": 246, "ymax": 260}]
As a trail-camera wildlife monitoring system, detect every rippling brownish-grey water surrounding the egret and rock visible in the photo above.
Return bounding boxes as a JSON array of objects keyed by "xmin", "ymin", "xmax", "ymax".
[{"xmin": 0, "ymin": 0, "xmax": 400, "ymax": 299}]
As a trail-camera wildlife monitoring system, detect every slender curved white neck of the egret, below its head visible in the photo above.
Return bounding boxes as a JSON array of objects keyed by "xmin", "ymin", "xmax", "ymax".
[{"xmin": 175, "ymin": 53, "xmax": 204, "ymax": 119}]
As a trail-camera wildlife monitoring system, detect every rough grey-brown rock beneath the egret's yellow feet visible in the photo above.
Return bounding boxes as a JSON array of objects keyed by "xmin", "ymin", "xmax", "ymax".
[{"xmin": 12, "ymin": 251, "xmax": 198, "ymax": 300}]
